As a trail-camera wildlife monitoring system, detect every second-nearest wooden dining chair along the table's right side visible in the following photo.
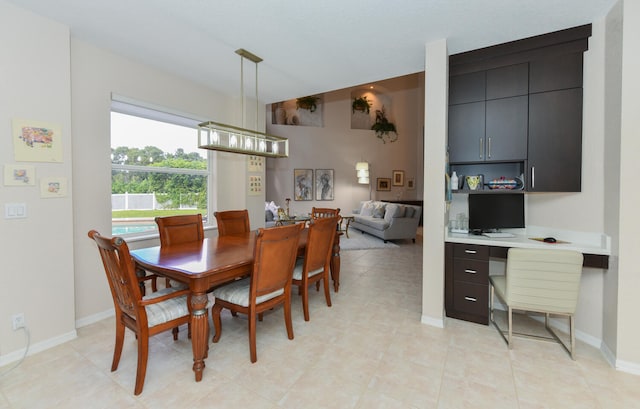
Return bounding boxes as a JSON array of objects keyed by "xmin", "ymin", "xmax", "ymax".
[{"xmin": 292, "ymin": 216, "xmax": 340, "ymax": 321}]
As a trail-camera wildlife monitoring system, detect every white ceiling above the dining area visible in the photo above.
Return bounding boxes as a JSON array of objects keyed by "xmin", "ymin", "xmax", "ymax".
[{"xmin": 9, "ymin": 0, "xmax": 616, "ymax": 103}]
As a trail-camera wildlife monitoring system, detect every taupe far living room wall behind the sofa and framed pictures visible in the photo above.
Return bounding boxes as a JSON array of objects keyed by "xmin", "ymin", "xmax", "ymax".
[{"xmin": 266, "ymin": 74, "xmax": 424, "ymax": 214}]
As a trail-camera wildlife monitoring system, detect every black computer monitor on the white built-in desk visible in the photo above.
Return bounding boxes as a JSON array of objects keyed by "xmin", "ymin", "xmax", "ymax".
[{"xmin": 469, "ymin": 193, "xmax": 525, "ymax": 232}]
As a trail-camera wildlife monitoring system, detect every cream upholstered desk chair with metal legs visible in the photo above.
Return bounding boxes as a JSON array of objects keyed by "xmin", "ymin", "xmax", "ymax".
[{"xmin": 489, "ymin": 248, "xmax": 583, "ymax": 360}]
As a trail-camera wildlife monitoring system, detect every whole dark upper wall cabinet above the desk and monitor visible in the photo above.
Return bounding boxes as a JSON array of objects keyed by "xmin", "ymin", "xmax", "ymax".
[{"xmin": 448, "ymin": 25, "xmax": 591, "ymax": 192}]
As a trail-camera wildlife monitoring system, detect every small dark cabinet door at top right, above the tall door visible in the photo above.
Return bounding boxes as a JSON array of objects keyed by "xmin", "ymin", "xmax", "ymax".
[{"xmin": 529, "ymin": 53, "xmax": 582, "ymax": 93}]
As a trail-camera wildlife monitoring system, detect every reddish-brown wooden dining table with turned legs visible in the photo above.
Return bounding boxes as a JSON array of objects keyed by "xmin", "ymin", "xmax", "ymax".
[{"xmin": 131, "ymin": 229, "xmax": 341, "ymax": 382}]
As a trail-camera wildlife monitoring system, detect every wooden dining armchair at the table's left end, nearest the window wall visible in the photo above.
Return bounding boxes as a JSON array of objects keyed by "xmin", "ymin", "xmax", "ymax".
[{"xmin": 89, "ymin": 230, "xmax": 190, "ymax": 395}]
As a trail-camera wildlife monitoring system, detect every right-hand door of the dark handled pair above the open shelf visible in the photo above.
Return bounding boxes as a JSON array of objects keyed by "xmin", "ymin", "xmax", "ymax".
[{"xmin": 485, "ymin": 95, "xmax": 529, "ymax": 161}]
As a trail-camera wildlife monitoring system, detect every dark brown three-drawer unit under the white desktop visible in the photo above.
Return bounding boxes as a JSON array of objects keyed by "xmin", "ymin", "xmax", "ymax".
[{"xmin": 445, "ymin": 243, "xmax": 489, "ymax": 325}]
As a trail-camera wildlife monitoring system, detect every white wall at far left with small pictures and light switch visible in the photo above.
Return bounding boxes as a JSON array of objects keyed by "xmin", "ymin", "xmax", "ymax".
[{"xmin": 0, "ymin": 0, "xmax": 75, "ymax": 365}]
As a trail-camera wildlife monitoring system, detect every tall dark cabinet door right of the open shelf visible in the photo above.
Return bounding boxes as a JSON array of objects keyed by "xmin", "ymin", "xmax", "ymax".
[{"xmin": 527, "ymin": 88, "xmax": 582, "ymax": 192}]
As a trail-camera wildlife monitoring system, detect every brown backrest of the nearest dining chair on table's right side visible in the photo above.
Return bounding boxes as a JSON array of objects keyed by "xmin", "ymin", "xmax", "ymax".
[{"xmin": 250, "ymin": 223, "xmax": 304, "ymax": 305}]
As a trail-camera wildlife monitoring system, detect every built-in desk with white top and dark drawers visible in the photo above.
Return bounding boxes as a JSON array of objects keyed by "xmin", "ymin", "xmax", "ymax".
[{"xmin": 445, "ymin": 227, "xmax": 611, "ymax": 325}]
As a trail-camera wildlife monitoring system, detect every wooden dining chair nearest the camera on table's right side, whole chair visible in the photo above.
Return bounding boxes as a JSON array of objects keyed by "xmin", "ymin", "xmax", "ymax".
[{"xmin": 211, "ymin": 224, "xmax": 304, "ymax": 363}]
